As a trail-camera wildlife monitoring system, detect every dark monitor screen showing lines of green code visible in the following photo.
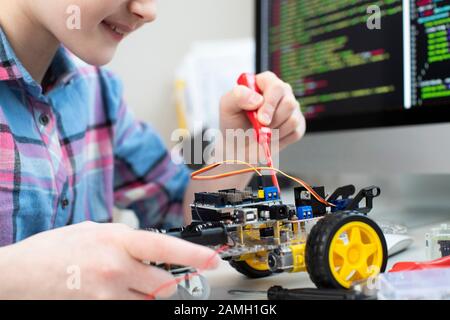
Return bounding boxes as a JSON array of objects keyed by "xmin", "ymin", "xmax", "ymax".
[{"xmin": 257, "ymin": 0, "xmax": 450, "ymax": 131}]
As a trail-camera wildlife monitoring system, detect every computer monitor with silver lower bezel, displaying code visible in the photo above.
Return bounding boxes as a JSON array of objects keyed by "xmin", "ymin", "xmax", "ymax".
[{"xmin": 257, "ymin": 0, "xmax": 450, "ymax": 173}]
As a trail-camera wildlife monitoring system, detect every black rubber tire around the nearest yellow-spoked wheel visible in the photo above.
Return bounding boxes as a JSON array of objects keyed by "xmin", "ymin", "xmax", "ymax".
[{"xmin": 305, "ymin": 213, "xmax": 388, "ymax": 289}]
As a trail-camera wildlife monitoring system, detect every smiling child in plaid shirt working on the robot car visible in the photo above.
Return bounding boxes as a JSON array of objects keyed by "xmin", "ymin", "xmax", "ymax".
[{"xmin": 0, "ymin": 0, "xmax": 305, "ymax": 299}]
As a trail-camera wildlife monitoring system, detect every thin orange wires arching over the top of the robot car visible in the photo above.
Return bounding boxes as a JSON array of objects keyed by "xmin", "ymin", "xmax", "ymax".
[{"xmin": 191, "ymin": 160, "xmax": 334, "ymax": 207}]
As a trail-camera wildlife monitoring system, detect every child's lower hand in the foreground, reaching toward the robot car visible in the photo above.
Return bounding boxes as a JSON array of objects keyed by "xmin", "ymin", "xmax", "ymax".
[{"xmin": 0, "ymin": 222, "xmax": 220, "ymax": 299}]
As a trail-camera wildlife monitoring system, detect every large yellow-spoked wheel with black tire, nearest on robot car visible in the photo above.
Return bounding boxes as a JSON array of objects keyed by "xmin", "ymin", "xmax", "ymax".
[{"xmin": 306, "ymin": 213, "xmax": 387, "ymax": 288}]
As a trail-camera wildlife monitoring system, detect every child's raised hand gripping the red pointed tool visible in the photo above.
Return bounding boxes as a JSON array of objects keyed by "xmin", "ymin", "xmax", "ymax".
[{"xmin": 220, "ymin": 72, "xmax": 306, "ymax": 149}]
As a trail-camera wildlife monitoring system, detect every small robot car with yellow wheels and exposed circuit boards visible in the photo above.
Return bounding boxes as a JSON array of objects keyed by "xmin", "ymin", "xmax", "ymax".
[{"xmin": 155, "ymin": 185, "xmax": 387, "ymax": 298}]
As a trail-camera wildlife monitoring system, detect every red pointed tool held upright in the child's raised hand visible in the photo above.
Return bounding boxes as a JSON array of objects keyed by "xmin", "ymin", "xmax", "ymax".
[{"xmin": 237, "ymin": 73, "xmax": 280, "ymax": 193}]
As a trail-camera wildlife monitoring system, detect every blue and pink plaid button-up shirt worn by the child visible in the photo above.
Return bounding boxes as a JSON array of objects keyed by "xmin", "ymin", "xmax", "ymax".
[{"xmin": 0, "ymin": 29, "xmax": 189, "ymax": 246}]
